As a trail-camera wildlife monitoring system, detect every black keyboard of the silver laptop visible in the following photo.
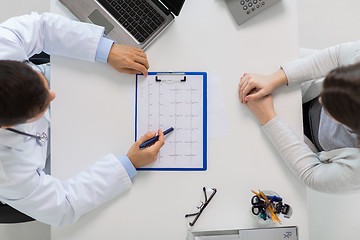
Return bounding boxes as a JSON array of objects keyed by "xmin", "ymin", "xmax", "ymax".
[{"xmin": 97, "ymin": 0, "xmax": 165, "ymax": 43}]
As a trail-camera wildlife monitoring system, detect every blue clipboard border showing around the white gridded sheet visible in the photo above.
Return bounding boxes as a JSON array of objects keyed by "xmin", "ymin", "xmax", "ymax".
[{"xmin": 135, "ymin": 72, "xmax": 207, "ymax": 171}]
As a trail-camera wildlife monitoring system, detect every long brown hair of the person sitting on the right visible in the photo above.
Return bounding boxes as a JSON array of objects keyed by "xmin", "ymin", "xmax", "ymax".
[{"xmin": 320, "ymin": 63, "xmax": 360, "ymax": 144}]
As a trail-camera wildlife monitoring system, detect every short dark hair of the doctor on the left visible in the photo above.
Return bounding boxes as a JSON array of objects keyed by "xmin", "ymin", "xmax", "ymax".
[{"xmin": 0, "ymin": 60, "xmax": 49, "ymax": 126}]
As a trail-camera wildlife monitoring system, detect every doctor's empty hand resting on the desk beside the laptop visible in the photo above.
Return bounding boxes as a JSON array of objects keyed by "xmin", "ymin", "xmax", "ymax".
[{"xmin": 108, "ymin": 44, "xmax": 149, "ymax": 76}]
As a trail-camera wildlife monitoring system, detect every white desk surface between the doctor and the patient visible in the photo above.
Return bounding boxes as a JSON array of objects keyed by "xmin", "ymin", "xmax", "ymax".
[{"xmin": 51, "ymin": 0, "xmax": 309, "ymax": 240}]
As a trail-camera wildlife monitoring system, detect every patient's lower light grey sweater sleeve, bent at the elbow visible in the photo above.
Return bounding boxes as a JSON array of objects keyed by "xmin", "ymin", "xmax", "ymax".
[{"xmin": 262, "ymin": 117, "xmax": 360, "ymax": 192}]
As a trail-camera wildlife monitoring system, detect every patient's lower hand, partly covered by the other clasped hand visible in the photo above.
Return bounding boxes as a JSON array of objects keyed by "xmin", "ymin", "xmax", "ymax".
[{"xmin": 246, "ymin": 94, "xmax": 276, "ymax": 125}]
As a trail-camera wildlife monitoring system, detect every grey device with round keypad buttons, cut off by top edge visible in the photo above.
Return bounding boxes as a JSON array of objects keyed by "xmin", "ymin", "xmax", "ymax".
[{"xmin": 225, "ymin": 0, "xmax": 280, "ymax": 25}]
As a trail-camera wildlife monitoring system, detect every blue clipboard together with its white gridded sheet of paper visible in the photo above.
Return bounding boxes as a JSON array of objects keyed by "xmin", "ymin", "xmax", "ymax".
[{"xmin": 135, "ymin": 72, "xmax": 207, "ymax": 171}]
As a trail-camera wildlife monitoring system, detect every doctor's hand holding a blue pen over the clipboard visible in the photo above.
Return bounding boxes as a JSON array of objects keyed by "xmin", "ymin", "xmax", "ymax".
[{"xmin": 126, "ymin": 129, "xmax": 164, "ymax": 168}]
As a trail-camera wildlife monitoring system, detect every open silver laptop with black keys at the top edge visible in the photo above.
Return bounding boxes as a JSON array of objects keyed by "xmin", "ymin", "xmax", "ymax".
[{"xmin": 59, "ymin": 0, "xmax": 185, "ymax": 49}]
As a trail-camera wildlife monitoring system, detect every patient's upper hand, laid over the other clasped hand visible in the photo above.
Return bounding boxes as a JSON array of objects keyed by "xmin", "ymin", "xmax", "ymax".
[{"xmin": 239, "ymin": 69, "xmax": 288, "ymax": 103}]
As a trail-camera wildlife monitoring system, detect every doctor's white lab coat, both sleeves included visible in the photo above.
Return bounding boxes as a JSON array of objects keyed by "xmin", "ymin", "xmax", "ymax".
[{"xmin": 0, "ymin": 13, "xmax": 131, "ymax": 226}]
